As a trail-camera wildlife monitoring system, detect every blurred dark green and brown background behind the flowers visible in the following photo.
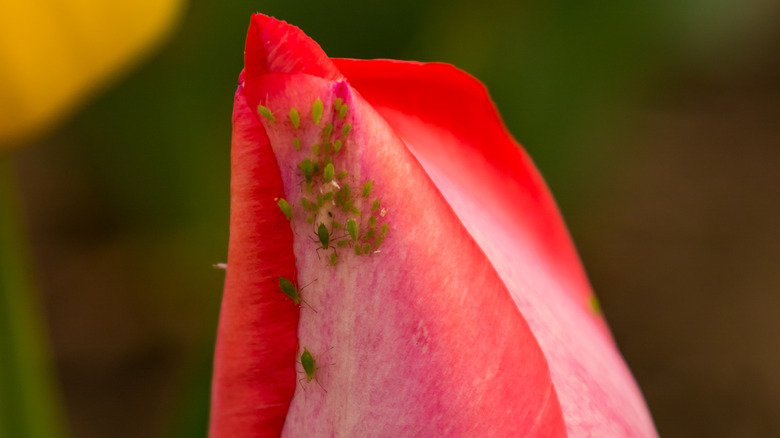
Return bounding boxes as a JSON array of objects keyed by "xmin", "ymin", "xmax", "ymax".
[{"xmin": 0, "ymin": 0, "xmax": 780, "ymax": 438}]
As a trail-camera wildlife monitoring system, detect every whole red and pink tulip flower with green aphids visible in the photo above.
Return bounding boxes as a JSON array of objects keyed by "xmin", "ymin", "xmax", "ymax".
[{"xmin": 210, "ymin": 15, "xmax": 656, "ymax": 438}]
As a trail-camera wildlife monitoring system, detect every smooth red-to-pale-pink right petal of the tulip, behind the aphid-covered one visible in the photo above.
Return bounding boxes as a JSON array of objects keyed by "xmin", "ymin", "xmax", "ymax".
[{"xmin": 334, "ymin": 59, "xmax": 656, "ymax": 437}]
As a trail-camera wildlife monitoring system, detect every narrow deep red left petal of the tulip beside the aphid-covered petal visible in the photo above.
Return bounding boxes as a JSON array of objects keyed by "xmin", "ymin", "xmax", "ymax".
[{"xmin": 209, "ymin": 87, "xmax": 299, "ymax": 437}]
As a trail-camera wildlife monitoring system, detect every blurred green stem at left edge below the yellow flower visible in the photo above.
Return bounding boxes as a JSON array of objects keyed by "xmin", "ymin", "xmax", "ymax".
[{"xmin": 0, "ymin": 155, "xmax": 64, "ymax": 438}]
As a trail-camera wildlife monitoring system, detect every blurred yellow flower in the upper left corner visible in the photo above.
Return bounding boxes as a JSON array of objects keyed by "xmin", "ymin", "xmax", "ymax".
[{"xmin": 0, "ymin": 0, "xmax": 184, "ymax": 149}]
